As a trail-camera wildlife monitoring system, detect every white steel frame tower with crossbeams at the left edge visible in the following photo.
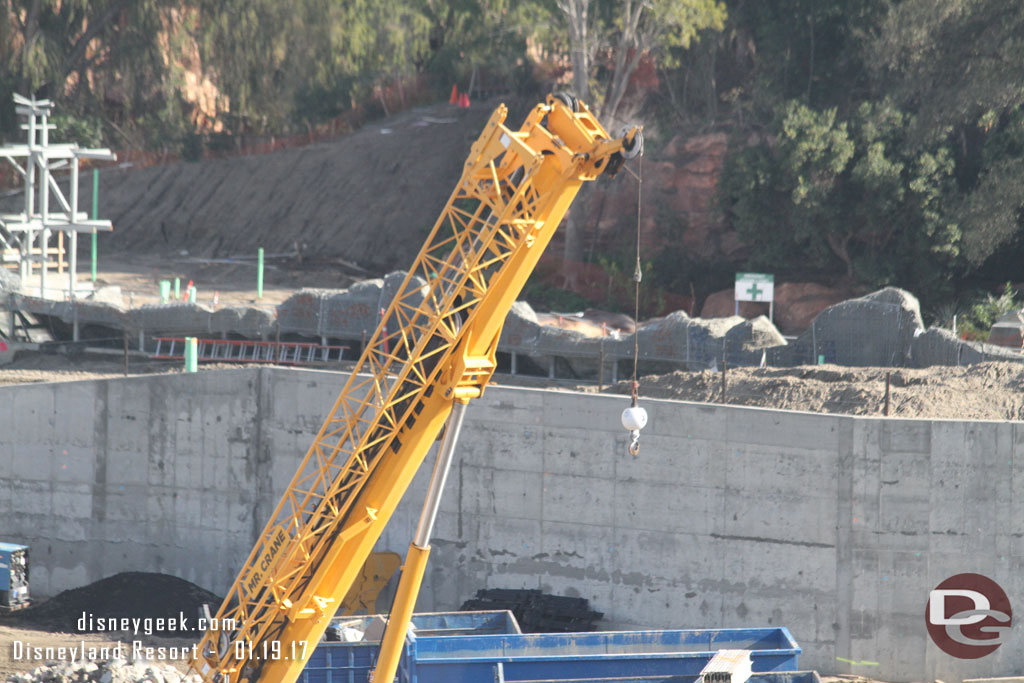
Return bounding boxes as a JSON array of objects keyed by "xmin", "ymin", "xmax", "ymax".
[{"xmin": 0, "ymin": 94, "xmax": 116, "ymax": 299}]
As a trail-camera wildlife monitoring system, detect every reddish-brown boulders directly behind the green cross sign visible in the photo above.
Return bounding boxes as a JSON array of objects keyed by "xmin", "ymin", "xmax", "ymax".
[{"xmin": 700, "ymin": 283, "xmax": 849, "ymax": 335}]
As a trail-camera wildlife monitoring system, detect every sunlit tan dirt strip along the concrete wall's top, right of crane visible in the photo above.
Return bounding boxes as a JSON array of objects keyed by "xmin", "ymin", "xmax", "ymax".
[{"xmin": 598, "ymin": 362, "xmax": 1024, "ymax": 420}]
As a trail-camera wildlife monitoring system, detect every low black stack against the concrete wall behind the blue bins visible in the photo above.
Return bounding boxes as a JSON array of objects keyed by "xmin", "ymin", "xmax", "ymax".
[{"xmin": 460, "ymin": 588, "xmax": 604, "ymax": 633}]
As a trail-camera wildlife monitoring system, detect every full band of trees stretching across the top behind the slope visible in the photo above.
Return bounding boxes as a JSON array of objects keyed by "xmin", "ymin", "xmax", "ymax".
[{"xmin": 6, "ymin": 0, "xmax": 1024, "ymax": 307}]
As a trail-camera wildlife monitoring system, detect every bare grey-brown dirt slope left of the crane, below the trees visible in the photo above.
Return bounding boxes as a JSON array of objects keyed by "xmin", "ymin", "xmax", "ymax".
[{"xmin": 59, "ymin": 104, "xmax": 495, "ymax": 271}]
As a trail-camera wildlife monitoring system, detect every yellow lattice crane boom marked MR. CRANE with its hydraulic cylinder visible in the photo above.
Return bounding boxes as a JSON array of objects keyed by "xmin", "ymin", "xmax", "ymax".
[{"xmin": 190, "ymin": 94, "xmax": 643, "ymax": 683}]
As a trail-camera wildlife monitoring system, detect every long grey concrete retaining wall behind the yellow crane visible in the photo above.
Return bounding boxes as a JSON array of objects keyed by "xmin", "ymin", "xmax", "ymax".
[{"xmin": 0, "ymin": 368, "xmax": 1024, "ymax": 681}]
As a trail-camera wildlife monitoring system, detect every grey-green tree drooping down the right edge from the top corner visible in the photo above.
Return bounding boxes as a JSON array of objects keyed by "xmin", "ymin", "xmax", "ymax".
[{"xmin": 868, "ymin": 0, "xmax": 1024, "ymax": 269}]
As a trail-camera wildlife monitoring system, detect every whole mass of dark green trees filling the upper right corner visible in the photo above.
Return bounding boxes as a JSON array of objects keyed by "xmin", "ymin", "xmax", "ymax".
[{"xmin": 722, "ymin": 0, "xmax": 1024, "ymax": 299}]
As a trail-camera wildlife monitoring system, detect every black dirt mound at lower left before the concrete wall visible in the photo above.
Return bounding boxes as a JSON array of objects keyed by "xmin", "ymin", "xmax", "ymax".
[{"xmin": 4, "ymin": 571, "xmax": 222, "ymax": 637}]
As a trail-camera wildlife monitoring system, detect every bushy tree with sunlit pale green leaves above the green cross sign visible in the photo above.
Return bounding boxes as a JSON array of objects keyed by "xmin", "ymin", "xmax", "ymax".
[{"xmin": 722, "ymin": 101, "xmax": 961, "ymax": 287}]
